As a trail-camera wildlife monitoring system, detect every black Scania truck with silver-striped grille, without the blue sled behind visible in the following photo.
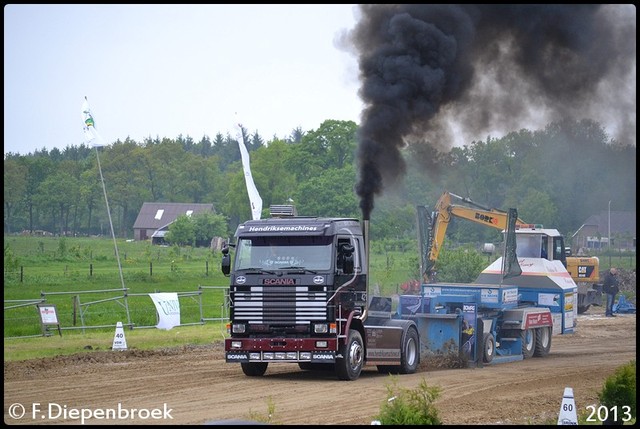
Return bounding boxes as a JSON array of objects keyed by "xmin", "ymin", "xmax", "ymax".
[{"xmin": 222, "ymin": 206, "xmax": 420, "ymax": 380}]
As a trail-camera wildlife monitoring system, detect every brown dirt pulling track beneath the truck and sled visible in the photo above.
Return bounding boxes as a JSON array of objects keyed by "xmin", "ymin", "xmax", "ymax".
[{"xmin": 4, "ymin": 307, "xmax": 636, "ymax": 425}]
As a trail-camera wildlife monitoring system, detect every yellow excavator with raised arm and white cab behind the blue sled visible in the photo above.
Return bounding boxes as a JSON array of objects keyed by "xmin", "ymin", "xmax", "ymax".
[{"xmin": 418, "ymin": 191, "xmax": 602, "ymax": 314}]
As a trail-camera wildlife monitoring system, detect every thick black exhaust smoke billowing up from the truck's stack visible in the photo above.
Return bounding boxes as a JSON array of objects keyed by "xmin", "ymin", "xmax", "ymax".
[{"xmin": 348, "ymin": 4, "xmax": 636, "ymax": 219}]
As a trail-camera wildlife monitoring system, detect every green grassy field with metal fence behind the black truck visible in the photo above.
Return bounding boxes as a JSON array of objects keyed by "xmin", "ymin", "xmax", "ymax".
[{"xmin": 4, "ymin": 236, "xmax": 417, "ymax": 360}]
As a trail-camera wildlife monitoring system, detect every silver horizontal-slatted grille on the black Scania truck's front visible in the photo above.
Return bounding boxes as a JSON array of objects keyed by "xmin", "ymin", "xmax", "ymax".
[{"xmin": 230, "ymin": 286, "xmax": 329, "ymax": 325}]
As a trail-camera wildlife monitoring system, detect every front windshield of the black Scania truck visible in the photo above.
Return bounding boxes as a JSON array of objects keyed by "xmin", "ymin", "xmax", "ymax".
[{"xmin": 235, "ymin": 237, "xmax": 334, "ymax": 271}]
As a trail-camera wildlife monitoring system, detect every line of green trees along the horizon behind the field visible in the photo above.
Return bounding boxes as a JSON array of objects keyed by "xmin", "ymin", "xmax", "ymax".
[{"xmin": 4, "ymin": 119, "xmax": 636, "ymax": 246}]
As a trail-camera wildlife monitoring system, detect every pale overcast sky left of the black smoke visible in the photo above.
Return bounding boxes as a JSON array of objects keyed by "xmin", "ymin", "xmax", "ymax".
[{"xmin": 4, "ymin": 4, "xmax": 362, "ymax": 154}]
